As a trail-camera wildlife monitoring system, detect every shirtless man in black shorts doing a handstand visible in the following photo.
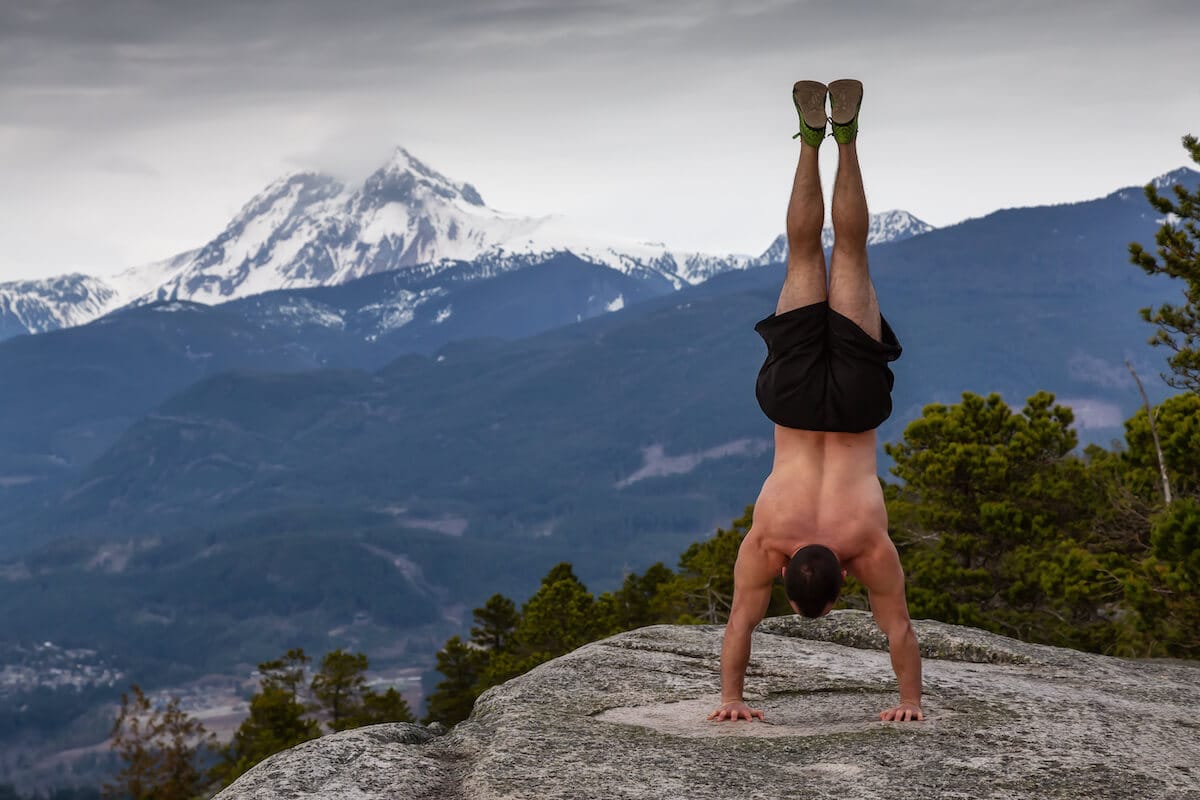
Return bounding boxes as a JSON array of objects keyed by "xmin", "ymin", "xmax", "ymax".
[{"xmin": 708, "ymin": 80, "xmax": 924, "ymax": 722}]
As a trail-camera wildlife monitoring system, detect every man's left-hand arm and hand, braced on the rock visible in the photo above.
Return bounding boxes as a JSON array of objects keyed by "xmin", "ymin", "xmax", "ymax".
[{"xmin": 708, "ymin": 531, "xmax": 774, "ymax": 721}]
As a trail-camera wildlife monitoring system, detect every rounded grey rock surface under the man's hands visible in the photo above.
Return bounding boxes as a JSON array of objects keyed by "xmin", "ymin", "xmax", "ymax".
[{"xmin": 217, "ymin": 610, "xmax": 1200, "ymax": 800}]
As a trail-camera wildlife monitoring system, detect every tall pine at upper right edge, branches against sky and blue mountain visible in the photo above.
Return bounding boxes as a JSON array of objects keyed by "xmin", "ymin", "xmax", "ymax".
[{"xmin": 1129, "ymin": 136, "xmax": 1200, "ymax": 393}]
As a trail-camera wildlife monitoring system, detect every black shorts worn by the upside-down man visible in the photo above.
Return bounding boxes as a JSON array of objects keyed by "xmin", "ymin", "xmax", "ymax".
[{"xmin": 754, "ymin": 302, "xmax": 900, "ymax": 433}]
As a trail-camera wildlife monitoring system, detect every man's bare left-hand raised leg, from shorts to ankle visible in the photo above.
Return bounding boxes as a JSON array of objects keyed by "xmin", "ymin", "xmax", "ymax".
[{"xmin": 775, "ymin": 144, "xmax": 828, "ymax": 314}]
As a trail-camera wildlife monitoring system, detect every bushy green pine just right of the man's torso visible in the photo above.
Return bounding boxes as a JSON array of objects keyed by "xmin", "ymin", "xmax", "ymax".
[{"xmin": 884, "ymin": 392, "xmax": 1120, "ymax": 649}]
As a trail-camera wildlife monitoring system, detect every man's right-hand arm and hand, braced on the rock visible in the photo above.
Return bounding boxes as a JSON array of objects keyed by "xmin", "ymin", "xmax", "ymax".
[{"xmin": 862, "ymin": 539, "xmax": 925, "ymax": 722}]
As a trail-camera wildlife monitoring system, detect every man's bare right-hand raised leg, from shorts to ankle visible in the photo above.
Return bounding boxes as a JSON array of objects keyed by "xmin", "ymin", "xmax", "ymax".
[{"xmin": 829, "ymin": 142, "xmax": 882, "ymax": 339}]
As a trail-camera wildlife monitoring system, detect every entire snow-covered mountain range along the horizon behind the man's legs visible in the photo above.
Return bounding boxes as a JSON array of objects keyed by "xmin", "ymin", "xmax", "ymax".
[{"xmin": 0, "ymin": 148, "xmax": 929, "ymax": 338}]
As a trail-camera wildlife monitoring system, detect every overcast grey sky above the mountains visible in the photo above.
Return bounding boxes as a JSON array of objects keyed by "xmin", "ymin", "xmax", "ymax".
[{"xmin": 0, "ymin": 0, "xmax": 1200, "ymax": 281}]
